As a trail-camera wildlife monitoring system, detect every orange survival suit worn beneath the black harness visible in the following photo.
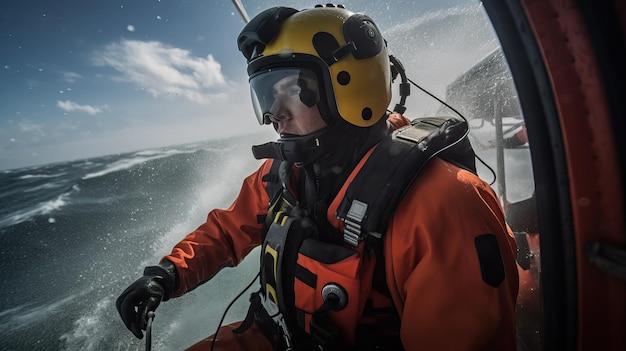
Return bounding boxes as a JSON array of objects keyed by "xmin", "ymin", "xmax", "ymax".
[{"xmin": 163, "ymin": 115, "xmax": 518, "ymax": 350}]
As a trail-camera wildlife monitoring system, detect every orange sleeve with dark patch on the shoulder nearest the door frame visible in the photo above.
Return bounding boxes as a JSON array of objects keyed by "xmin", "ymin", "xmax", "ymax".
[{"xmin": 385, "ymin": 158, "xmax": 518, "ymax": 351}]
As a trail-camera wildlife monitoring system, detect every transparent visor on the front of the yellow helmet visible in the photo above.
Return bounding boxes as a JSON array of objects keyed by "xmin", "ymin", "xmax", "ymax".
[{"xmin": 250, "ymin": 68, "xmax": 320, "ymax": 124}]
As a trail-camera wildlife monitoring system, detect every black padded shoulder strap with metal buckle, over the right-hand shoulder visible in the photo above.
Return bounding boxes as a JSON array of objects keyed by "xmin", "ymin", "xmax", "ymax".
[{"xmin": 337, "ymin": 117, "xmax": 476, "ymax": 246}]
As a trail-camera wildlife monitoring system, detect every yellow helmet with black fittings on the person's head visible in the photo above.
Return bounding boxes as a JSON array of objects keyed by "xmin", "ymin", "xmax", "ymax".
[{"xmin": 237, "ymin": 5, "xmax": 392, "ymax": 127}]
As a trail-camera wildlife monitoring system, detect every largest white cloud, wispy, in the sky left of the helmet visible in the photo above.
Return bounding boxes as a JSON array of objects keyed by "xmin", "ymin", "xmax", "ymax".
[{"xmin": 93, "ymin": 40, "xmax": 227, "ymax": 103}]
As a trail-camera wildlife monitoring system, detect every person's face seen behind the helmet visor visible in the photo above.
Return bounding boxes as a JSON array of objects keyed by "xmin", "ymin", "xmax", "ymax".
[{"xmin": 269, "ymin": 75, "xmax": 326, "ymax": 136}]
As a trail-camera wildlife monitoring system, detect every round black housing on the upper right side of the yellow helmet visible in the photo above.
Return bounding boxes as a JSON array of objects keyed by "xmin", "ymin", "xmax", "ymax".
[{"xmin": 343, "ymin": 14, "xmax": 384, "ymax": 59}]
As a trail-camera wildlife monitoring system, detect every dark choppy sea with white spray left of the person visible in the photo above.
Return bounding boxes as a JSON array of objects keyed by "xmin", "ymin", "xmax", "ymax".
[{"xmin": 0, "ymin": 136, "xmax": 263, "ymax": 350}]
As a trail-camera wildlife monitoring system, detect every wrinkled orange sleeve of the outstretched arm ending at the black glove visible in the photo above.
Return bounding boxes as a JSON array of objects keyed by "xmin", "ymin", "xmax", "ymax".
[{"xmin": 162, "ymin": 161, "xmax": 271, "ymax": 296}]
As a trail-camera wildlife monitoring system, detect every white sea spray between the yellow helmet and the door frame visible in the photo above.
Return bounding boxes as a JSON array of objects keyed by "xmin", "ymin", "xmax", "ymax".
[{"xmin": 384, "ymin": 3, "xmax": 499, "ymax": 118}]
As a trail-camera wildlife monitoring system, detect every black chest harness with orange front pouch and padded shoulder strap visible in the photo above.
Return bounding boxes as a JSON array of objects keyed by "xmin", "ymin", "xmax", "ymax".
[{"xmin": 235, "ymin": 117, "xmax": 476, "ymax": 350}]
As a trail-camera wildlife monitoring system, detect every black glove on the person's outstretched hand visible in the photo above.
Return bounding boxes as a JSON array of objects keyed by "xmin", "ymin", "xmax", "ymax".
[{"xmin": 115, "ymin": 261, "xmax": 177, "ymax": 339}]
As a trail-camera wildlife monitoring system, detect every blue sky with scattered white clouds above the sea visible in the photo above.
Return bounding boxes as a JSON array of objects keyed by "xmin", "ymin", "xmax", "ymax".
[{"xmin": 0, "ymin": 0, "xmax": 493, "ymax": 169}]
